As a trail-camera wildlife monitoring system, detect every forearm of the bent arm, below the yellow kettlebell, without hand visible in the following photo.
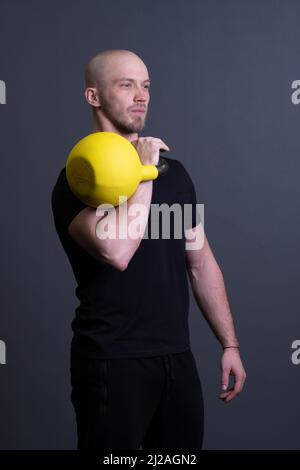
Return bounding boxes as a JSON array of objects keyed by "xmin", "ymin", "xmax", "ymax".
[{"xmin": 95, "ymin": 181, "xmax": 153, "ymax": 265}]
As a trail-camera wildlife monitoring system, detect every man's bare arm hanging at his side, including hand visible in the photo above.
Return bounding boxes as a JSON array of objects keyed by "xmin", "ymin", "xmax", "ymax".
[{"xmin": 185, "ymin": 223, "xmax": 246, "ymax": 402}]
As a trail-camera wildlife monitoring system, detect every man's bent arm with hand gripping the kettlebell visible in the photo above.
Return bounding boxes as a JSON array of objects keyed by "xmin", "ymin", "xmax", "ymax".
[{"xmin": 68, "ymin": 137, "xmax": 170, "ymax": 271}]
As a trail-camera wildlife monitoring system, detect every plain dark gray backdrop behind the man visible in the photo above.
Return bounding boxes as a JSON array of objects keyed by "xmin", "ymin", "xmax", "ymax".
[{"xmin": 0, "ymin": 0, "xmax": 300, "ymax": 449}]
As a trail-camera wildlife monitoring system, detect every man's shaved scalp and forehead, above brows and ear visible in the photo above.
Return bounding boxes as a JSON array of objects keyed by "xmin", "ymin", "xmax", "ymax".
[{"xmin": 85, "ymin": 49, "xmax": 148, "ymax": 89}]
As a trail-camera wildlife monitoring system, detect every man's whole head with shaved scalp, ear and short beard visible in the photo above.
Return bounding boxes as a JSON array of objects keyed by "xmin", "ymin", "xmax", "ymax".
[{"xmin": 84, "ymin": 49, "xmax": 150, "ymax": 138}]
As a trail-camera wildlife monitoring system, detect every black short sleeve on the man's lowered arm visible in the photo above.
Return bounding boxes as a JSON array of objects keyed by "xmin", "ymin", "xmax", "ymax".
[{"xmin": 177, "ymin": 160, "xmax": 201, "ymax": 230}]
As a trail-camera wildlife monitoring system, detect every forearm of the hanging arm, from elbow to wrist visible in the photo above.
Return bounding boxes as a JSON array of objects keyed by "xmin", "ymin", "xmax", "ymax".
[{"xmin": 188, "ymin": 259, "xmax": 238, "ymax": 347}]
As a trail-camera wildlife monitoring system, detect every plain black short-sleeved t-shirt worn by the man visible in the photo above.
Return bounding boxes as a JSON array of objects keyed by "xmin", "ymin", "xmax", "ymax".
[{"xmin": 51, "ymin": 157, "xmax": 200, "ymax": 358}]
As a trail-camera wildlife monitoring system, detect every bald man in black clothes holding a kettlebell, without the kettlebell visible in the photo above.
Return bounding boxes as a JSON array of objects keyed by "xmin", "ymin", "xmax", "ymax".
[{"xmin": 52, "ymin": 50, "xmax": 246, "ymax": 451}]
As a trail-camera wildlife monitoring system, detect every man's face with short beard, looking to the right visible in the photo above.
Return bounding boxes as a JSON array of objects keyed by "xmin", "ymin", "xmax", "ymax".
[{"xmin": 99, "ymin": 58, "xmax": 150, "ymax": 133}]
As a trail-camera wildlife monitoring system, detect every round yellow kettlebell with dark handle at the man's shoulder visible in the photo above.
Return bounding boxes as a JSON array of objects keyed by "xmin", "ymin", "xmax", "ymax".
[{"xmin": 66, "ymin": 132, "xmax": 167, "ymax": 208}]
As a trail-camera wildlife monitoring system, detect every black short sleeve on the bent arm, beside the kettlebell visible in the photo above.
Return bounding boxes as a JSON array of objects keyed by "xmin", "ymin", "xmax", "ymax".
[{"xmin": 51, "ymin": 169, "xmax": 88, "ymax": 234}]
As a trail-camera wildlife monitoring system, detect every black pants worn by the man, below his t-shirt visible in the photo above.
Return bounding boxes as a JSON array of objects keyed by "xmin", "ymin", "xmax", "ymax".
[{"xmin": 71, "ymin": 350, "xmax": 203, "ymax": 451}]
